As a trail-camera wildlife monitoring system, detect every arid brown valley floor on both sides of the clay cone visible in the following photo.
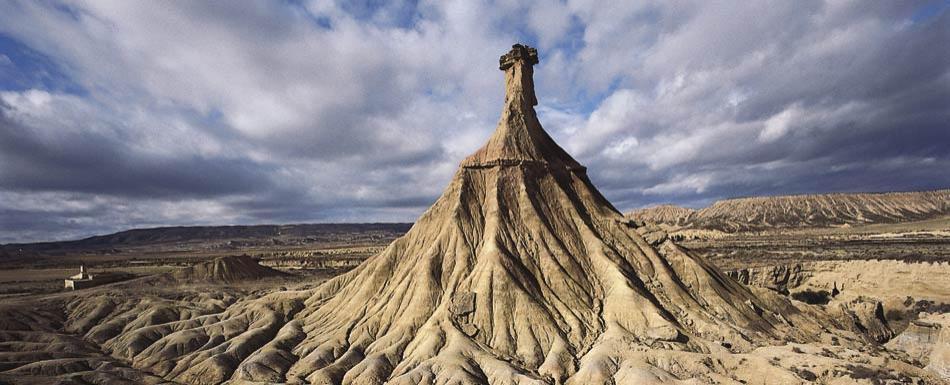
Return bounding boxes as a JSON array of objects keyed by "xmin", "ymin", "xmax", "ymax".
[{"xmin": 0, "ymin": 206, "xmax": 950, "ymax": 384}]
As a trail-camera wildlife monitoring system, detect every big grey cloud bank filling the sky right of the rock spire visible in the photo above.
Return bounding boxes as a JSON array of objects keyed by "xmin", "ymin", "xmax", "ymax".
[{"xmin": 567, "ymin": 2, "xmax": 950, "ymax": 208}]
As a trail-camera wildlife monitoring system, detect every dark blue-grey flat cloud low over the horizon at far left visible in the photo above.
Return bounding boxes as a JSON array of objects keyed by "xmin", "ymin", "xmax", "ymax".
[{"xmin": 0, "ymin": 111, "xmax": 274, "ymax": 198}]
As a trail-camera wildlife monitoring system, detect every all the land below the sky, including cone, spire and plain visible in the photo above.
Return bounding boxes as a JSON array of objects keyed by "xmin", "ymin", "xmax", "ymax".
[{"xmin": 0, "ymin": 45, "xmax": 950, "ymax": 385}]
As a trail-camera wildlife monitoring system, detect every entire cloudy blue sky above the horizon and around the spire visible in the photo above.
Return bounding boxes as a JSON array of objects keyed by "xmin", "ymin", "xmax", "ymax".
[{"xmin": 0, "ymin": 0, "xmax": 950, "ymax": 243}]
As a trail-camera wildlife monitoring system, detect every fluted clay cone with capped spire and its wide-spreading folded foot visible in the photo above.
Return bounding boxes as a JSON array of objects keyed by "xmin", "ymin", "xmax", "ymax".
[{"xmin": 0, "ymin": 46, "xmax": 939, "ymax": 385}]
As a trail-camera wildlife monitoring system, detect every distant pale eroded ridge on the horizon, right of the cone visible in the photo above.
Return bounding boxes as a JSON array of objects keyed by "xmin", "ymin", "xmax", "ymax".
[{"xmin": 627, "ymin": 189, "xmax": 950, "ymax": 232}]
